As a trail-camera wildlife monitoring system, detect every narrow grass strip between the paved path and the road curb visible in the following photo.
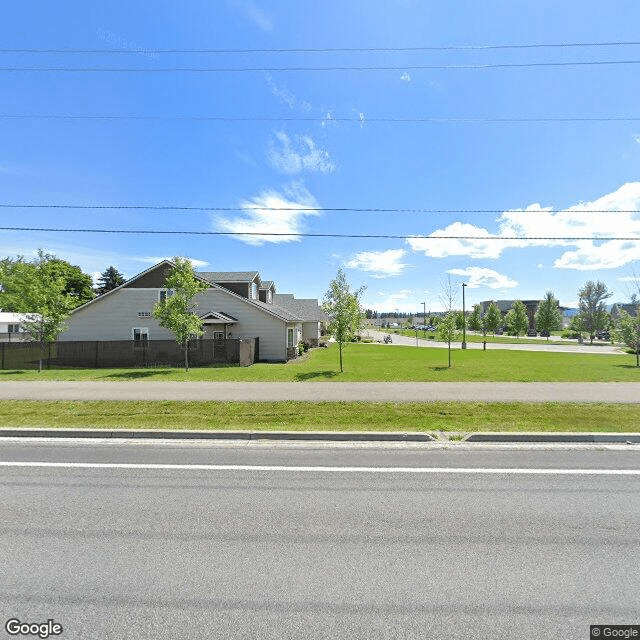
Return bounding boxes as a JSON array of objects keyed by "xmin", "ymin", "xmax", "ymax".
[{"xmin": 0, "ymin": 400, "xmax": 640, "ymax": 432}]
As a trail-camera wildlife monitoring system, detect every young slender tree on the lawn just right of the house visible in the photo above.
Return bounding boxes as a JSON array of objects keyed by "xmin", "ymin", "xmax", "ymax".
[{"xmin": 322, "ymin": 269, "xmax": 366, "ymax": 373}]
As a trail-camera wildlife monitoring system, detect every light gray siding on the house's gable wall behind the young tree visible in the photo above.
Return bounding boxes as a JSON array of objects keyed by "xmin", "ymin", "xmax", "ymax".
[{"xmin": 59, "ymin": 288, "xmax": 287, "ymax": 360}]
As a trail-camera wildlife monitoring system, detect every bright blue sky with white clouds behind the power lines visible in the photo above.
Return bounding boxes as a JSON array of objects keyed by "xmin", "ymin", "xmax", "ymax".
[{"xmin": 0, "ymin": 0, "xmax": 640, "ymax": 311}]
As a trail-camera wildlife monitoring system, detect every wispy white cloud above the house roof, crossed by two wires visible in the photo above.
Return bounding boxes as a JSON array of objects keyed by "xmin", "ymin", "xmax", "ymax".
[{"xmin": 214, "ymin": 183, "xmax": 319, "ymax": 247}]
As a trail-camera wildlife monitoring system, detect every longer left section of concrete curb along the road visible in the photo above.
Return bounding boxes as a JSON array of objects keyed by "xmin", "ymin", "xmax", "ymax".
[{"xmin": 0, "ymin": 428, "xmax": 436, "ymax": 442}]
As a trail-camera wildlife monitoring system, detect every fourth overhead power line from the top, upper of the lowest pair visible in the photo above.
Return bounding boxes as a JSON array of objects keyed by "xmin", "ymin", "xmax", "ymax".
[{"xmin": 0, "ymin": 202, "xmax": 640, "ymax": 214}]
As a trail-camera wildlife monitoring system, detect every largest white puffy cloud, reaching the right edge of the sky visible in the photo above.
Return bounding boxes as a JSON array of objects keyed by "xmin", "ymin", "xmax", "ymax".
[{"xmin": 407, "ymin": 182, "xmax": 640, "ymax": 270}]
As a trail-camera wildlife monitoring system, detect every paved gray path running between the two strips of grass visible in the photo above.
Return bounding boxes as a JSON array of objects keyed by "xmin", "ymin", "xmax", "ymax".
[{"xmin": 0, "ymin": 381, "xmax": 640, "ymax": 404}]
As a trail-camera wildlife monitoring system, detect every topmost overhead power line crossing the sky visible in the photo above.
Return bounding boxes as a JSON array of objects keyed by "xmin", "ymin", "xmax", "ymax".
[{"xmin": 0, "ymin": 40, "xmax": 640, "ymax": 54}]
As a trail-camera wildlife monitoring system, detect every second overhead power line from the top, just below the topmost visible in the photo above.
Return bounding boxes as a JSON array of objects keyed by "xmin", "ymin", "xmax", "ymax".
[{"xmin": 0, "ymin": 60, "xmax": 640, "ymax": 73}]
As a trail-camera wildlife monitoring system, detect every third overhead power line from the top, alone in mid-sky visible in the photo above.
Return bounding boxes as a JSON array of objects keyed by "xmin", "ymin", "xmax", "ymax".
[{"xmin": 0, "ymin": 113, "xmax": 640, "ymax": 124}]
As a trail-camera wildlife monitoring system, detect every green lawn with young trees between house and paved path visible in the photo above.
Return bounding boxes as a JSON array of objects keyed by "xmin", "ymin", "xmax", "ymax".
[{"xmin": 0, "ymin": 344, "xmax": 640, "ymax": 382}]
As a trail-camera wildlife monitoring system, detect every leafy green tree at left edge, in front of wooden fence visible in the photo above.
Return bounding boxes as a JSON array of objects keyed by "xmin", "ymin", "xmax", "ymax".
[{"xmin": 0, "ymin": 252, "xmax": 77, "ymax": 371}]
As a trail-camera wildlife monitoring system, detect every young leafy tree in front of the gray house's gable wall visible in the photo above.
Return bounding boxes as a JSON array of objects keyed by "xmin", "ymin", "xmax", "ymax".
[{"xmin": 153, "ymin": 257, "xmax": 208, "ymax": 371}]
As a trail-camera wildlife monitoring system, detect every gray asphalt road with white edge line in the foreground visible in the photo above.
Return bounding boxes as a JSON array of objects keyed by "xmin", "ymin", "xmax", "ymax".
[{"xmin": 0, "ymin": 440, "xmax": 640, "ymax": 640}]
